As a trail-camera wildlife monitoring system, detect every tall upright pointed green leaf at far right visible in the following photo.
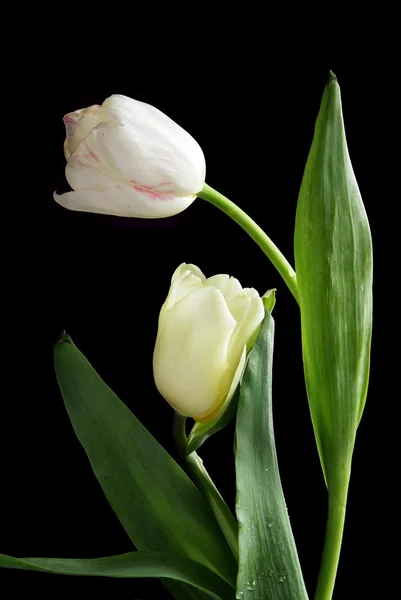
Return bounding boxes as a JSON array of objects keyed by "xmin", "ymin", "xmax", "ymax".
[{"xmin": 295, "ymin": 73, "xmax": 372, "ymax": 489}]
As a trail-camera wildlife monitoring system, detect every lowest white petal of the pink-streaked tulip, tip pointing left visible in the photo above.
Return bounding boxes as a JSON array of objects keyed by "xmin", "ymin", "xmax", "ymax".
[{"xmin": 54, "ymin": 184, "xmax": 195, "ymax": 219}]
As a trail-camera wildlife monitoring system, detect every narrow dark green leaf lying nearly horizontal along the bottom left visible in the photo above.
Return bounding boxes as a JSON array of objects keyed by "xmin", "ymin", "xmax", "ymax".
[{"xmin": 0, "ymin": 552, "xmax": 234, "ymax": 600}]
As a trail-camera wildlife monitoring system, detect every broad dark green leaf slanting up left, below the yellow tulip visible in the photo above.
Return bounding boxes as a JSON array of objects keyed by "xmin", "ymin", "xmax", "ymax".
[{"xmin": 54, "ymin": 335, "xmax": 237, "ymax": 587}]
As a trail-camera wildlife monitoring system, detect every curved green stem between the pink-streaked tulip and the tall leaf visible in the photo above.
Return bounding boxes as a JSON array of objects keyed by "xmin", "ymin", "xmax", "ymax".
[{"xmin": 198, "ymin": 183, "xmax": 299, "ymax": 303}]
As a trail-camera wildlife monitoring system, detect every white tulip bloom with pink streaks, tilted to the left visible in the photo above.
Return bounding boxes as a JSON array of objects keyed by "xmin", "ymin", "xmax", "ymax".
[{"xmin": 54, "ymin": 95, "xmax": 206, "ymax": 219}]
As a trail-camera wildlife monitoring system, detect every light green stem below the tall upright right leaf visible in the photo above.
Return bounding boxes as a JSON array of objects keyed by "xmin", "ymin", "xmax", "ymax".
[{"xmin": 315, "ymin": 482, "xmax": 348, "ymax": 600}]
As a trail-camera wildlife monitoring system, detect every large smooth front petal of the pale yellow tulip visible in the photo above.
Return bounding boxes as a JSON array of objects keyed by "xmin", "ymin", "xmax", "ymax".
[{"xmin": 153, "ymin": 287, "xmax": 235, "ymax": 418}]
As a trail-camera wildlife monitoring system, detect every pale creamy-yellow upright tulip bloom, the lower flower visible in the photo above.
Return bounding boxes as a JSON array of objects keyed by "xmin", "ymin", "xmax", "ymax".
[{"xmin": 153, "ymin": 263, "xmax": 264, "ymax": 423}]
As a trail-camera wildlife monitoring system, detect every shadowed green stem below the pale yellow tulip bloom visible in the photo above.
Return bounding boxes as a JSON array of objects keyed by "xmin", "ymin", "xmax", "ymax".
[{"xmin": 173, "ymin": 413, "xmax": 238, "ymax": 562}]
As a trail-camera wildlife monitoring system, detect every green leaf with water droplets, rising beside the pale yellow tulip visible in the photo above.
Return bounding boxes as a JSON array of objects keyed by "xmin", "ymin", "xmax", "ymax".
[{"xmin": 235, "ymin": 311, "xmax": 308, "ymax": 600}]
